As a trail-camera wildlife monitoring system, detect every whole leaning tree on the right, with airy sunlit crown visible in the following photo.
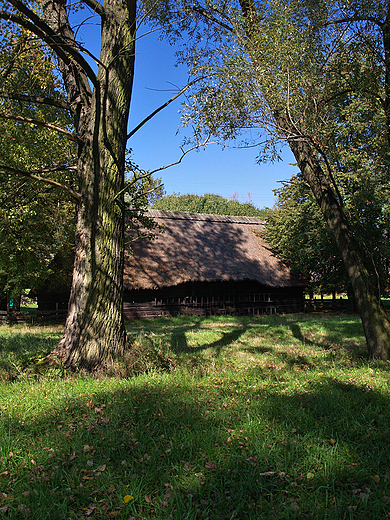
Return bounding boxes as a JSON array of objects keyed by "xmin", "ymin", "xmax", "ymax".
[{"xmin": 151, "ymin": 0, "xmax": 390, "ymax": 360}]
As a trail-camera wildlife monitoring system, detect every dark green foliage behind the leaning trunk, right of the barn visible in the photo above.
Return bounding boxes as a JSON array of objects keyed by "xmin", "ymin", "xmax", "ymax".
[{"xmin": 264, "ymin": 177, "xmax": 390, "ymax": 293}]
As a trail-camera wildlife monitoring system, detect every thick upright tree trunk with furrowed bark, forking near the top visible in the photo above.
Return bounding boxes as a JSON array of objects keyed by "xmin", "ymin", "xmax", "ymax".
[{"xmin": 45, "ymin": 0, "xmax": 136, "ymax": 371}]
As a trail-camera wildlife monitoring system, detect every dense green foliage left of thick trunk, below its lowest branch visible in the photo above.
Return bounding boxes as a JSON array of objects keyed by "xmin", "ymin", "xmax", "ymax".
[{"xmin": 0, "ymin": 182, "xmax": 76, "ymax": 301}]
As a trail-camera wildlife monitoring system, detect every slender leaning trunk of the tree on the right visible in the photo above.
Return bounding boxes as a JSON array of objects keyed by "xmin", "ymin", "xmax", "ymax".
[{"xmin": 289, "ymin": 136, "xmax": 390, "ymax": 360}]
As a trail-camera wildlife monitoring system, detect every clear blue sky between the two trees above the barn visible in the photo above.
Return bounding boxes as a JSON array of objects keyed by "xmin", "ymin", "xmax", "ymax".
[{"xmin": 84, "ymin": 17, "xmax": 297, "ymax": 208}]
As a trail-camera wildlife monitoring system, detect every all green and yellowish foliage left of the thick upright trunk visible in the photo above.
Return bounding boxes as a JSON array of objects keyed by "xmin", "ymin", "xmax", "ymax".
[{"xmin": 0, "ymin": 24, "xmax": 77, "ymax": 298}]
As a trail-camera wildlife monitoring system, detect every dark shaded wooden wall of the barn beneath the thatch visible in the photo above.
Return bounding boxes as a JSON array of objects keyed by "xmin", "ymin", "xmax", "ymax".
[{"xmin": 124, "ymin": 281, "xmax": 304, "ymax": 319}]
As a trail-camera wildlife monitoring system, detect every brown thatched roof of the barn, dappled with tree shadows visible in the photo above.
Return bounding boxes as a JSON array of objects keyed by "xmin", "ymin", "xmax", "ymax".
[{"xmin": 124, "ymin": 210, "xmax": 303, "ymax": 290}]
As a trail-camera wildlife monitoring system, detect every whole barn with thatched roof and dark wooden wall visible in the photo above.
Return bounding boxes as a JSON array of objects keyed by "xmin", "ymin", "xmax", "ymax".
[{"xmin": 124, "ymin": 210, "xmax": 304, "ymax": 318}]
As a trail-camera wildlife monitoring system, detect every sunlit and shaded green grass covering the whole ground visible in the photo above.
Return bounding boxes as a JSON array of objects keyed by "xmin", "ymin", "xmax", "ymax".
[{"xmin": 0, "ymin": 315, "xmax": 390, "ymax": 520}]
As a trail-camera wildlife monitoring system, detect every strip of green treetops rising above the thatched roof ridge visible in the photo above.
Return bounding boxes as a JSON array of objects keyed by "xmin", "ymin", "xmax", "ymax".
[{"xmin": 152, "ymin": 193, "xmax": 267, "ymax": 218}]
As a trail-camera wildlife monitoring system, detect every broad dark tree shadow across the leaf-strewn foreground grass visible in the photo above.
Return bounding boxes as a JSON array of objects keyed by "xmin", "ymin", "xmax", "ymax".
[{"xmin": 0, "ymin": 377, "xmax": 390, "ymax": 520}]
